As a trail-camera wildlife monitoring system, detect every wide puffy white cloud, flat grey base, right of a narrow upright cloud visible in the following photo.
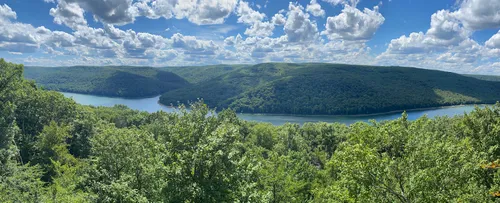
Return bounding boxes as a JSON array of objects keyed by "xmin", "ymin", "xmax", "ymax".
[{"xmin": 321, "ymin": 5, "xmax": 385, "ymax": 40}]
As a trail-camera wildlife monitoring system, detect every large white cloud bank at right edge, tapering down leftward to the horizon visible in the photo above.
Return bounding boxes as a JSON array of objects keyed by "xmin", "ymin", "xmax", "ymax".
[{"xmin": 377, "ymin": 0, "xmax": 500, "ymax": 73}]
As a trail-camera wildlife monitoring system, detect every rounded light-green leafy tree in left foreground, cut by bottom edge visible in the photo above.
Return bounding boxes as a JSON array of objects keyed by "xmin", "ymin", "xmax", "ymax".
[{"xmin": 86, "ymin": 125, "xmax": 169, "ymax": 202}]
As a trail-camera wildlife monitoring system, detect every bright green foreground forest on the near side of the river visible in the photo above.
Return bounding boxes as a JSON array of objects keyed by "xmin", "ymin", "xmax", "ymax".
[{"xmin": 0, "ymin": 59, "xmax": 500, "ymax": 202}]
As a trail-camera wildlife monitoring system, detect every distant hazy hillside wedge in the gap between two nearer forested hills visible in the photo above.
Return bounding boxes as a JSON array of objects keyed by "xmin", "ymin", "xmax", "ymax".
[{"xmin": 160, "ymin": 64, "xmax": 250, "ymax": 84}]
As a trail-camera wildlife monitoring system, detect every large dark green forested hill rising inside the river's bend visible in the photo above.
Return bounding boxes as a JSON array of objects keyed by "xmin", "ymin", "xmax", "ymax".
[{"xmin": 160, "ymin": 63, "xmax": 500, "ymax": 114}]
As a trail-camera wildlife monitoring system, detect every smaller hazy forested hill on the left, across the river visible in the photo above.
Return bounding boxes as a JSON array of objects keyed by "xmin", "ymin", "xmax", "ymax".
[{"xmin": 25, "ymin": 66, "xmax": 189, "ymax": 97}]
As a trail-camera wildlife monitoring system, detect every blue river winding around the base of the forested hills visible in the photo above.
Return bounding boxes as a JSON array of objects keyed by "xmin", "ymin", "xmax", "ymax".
[{"xmin": 62, "ymin": 92, "xmax": 485, "ymax": 125}]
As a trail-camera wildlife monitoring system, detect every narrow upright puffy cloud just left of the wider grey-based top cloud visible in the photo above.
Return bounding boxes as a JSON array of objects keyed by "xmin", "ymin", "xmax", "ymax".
[{"xmin": 284, "ymin": 2, "xmax": 318, "ymax": 42}]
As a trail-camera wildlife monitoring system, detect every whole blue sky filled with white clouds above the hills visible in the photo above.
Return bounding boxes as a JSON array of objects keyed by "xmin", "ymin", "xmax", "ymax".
[{"xmin": 0, "ymin": 0, "xmax": 500, "ymax": 75}]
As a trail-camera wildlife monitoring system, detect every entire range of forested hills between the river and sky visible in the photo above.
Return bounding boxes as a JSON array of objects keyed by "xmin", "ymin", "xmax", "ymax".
[{"xmin": 25, "ymin": 63, "xmax": 500, "ymax": 115}]
